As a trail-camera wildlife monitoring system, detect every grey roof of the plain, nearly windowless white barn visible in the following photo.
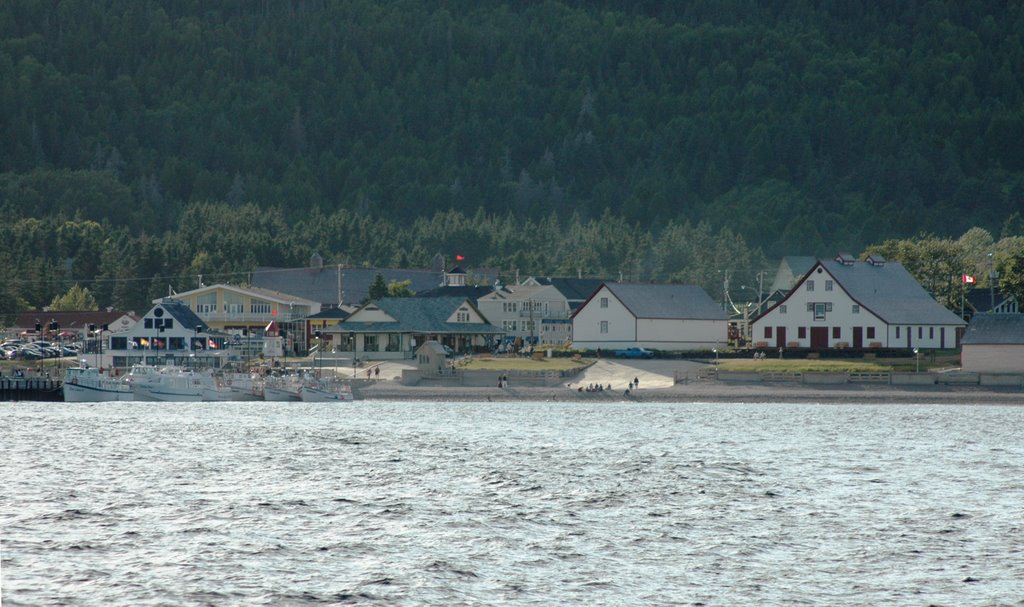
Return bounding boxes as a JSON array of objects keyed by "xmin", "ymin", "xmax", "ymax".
[{"xmin": 604, "ymin": 283, "xmax": 728, "ymax": 320}]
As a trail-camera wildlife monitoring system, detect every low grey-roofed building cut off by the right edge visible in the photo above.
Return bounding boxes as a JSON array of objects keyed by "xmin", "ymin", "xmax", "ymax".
[{"xmin": 961, "ymin": 314, "xmax": 1024, "ymax": 373}]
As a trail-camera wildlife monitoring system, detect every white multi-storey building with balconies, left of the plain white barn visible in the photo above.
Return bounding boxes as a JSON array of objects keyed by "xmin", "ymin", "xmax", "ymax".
[{"xmin": 476, "ymin": 285, "xmax": 572, "ymax": 344}]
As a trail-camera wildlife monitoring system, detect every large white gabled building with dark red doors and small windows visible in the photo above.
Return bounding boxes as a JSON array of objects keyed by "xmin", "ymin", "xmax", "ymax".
[{"xmin": 751, "ymin": 254, "xmax": 966, "ymax": 350}]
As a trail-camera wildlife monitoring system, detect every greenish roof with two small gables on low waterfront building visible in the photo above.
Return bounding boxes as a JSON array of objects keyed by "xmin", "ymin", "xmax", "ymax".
[{"xmin": 328, "ymin": 297, "xmax": 504, "ymax": 335}]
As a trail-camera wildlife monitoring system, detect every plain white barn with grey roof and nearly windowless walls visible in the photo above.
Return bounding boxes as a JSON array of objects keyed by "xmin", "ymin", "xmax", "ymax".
[{"xmin": 572, "ymin": 283, "xmax": 729, "ymax": 350}]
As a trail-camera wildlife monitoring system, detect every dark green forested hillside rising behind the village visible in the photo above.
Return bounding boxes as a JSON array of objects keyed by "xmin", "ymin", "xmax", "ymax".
[{"xmin": 0, "ymin": 0, "xmax": 1024, "ymax": 312}]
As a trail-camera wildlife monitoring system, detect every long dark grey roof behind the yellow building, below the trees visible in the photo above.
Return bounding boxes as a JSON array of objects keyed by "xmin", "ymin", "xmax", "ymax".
[{"xmin": 252, "ymin": 266, "xmax": 442, "ymax": 306}]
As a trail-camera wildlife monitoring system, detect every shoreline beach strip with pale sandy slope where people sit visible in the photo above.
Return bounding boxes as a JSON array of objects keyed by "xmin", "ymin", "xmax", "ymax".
[{"xmin": 359, "ymin": 359, "xmax": 1024, "ymax": 404}]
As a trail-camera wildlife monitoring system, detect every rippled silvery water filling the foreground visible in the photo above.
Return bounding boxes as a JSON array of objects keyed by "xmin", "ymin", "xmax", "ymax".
[{"xmin": 0, "ymin": 402, "xmax": 1024, "ymax": 607}]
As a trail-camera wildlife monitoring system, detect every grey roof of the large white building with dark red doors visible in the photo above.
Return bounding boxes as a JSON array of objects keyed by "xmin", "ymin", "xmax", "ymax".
[{"xmin": 811, "ymin": 260, "xmax": 964, "ymax": 324}]
